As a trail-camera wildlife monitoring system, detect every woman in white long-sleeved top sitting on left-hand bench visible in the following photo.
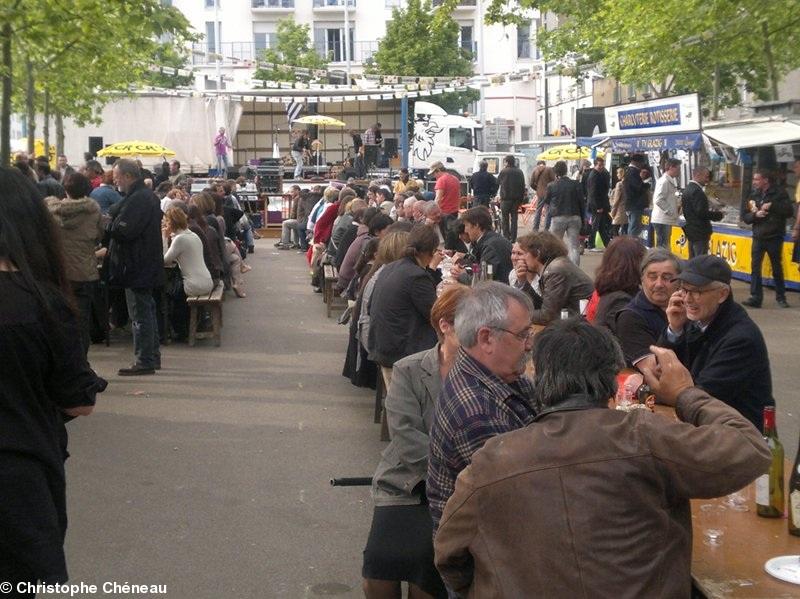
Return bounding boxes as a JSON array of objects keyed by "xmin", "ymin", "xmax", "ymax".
[{"xmin": 161, "ymin": 207, "xmax": 214, "ymax": 339}]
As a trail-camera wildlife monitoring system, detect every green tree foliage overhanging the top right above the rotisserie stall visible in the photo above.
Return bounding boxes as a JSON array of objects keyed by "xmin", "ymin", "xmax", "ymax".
[{"xmin": 482, "ymin": 0, "xmax": 800, "ymax": 112}]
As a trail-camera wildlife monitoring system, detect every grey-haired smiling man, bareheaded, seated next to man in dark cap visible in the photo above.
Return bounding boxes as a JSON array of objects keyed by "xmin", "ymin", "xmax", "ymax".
[{"xmin": 612, "ymin": 248, "xmax": 681, "ymax": 370}]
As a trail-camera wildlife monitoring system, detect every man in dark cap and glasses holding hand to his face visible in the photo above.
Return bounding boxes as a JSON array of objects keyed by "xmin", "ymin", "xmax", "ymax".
[{"xmin": 658, "ymin": 255, "xmax": 775, "ymax": 430}]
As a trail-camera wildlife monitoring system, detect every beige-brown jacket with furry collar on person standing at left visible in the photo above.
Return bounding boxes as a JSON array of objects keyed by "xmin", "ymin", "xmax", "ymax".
[{"xmin": 47, "ymin": 198, "xmax": 103, "ymax": 282}]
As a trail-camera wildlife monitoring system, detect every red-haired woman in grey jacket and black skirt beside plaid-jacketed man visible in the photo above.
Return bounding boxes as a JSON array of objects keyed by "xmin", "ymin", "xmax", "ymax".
[{"xmin": 362, "ymin": 284, "xmax": 469, "ymax": 599}]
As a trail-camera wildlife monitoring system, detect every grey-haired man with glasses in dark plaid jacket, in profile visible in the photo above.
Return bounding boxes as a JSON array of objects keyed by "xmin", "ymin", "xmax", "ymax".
[{"xmin": 426, "ymin": 281, "xmax": 538, "ymax": 530}]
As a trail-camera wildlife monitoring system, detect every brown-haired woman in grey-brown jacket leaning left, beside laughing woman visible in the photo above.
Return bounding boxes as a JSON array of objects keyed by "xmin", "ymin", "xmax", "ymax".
[{"xmin": 515, "ymin": 231, "xmax": 594, "ymax": 325}]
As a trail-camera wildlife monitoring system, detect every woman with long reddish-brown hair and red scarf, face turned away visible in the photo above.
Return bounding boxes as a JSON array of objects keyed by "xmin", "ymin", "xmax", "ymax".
[{"xmin": 586, "ymin": 235, "xmax": 646, "ymax": 333}]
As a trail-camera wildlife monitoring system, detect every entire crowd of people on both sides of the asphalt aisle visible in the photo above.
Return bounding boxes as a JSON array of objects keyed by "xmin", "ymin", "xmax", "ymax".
[{"xmin": 0, "ymin": 146, "xmax": 788, "ymax": 598}]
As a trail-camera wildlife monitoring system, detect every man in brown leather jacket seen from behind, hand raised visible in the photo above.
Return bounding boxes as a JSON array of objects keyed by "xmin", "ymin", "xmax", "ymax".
[{"xmin": 434, "ymin": 319, "xmax": 770, "ymax": 599}]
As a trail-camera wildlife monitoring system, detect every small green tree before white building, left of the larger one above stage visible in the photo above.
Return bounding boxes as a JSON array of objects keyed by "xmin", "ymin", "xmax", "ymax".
[{"xmin": 254, "ymin": 17, "xmax": 328, "ymax": 81}]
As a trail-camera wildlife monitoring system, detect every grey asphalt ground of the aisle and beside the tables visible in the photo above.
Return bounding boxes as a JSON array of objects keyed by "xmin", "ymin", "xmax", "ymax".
[{"xmin": 54, "ymin": 239, "xmax": 800, "ymax": 599}]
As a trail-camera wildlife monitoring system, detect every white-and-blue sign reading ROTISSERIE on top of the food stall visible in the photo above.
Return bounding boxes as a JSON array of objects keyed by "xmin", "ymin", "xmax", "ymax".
[{"xmin": 605, "ymin": 94, "xmax": 700, "ymax": 136}]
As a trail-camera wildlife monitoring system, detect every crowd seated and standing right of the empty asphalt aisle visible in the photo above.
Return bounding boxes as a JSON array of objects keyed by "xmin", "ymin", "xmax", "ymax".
[{"xmin": 280, "ymin": 160, "xmax": 774, "ymax": 597}]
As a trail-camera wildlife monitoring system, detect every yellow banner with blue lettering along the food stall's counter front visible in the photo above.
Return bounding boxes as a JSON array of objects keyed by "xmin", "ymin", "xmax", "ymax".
[{"xmin": 670, "ymin": 224, "xmax": 800, "ymax": 292}]
